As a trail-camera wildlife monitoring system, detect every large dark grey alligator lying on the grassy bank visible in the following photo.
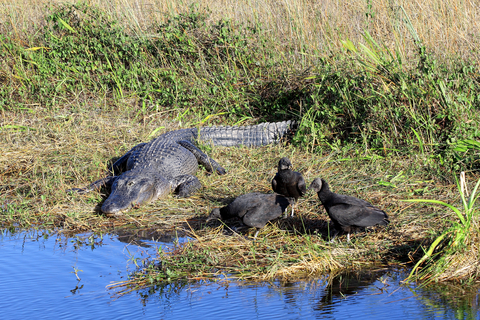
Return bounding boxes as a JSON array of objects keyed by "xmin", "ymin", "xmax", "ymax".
[{"xmin": 67, "ymin": 121, "xmax": 295, "ymax": 215}]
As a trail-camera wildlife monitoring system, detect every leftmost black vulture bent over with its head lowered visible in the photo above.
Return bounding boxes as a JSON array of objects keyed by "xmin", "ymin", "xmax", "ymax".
[{"xmin": 207, "ymin": 192, "xmax": 290, "ymax": 238}]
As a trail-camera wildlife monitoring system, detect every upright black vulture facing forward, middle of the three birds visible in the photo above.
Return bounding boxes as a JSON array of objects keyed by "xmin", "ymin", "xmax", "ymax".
[{"xmin": 272, "ymin": 157, "xmax": 307, "ymax": 217}]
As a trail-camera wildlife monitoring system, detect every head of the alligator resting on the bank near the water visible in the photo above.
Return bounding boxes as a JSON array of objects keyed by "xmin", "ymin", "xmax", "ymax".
[{"xmin": 101, "ymin": 170, "xmax": 171, "ymax": 214}]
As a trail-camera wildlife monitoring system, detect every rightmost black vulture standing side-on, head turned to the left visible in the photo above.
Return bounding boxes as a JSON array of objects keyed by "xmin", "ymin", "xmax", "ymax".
[{"xmin": 309, "ymin": 178, "xmax": 390, "ymax": 241}]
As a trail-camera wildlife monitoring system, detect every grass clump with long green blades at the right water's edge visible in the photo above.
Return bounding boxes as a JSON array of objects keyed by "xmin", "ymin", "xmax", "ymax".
[{"xmin": 409, "ymin": 172, "xmax": 480, "ymax": 284}]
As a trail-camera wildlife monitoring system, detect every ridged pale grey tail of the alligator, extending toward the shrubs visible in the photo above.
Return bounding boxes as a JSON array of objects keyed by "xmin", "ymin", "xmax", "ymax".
[{"xmin": 200, "ymin": 120, "xmax": 296, "ymax": 147}]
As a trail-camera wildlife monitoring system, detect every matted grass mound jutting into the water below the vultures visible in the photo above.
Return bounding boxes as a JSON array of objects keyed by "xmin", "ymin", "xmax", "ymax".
[{"xmin": 107, "ymin": 225, "xmax": 365, "ymax": 294}]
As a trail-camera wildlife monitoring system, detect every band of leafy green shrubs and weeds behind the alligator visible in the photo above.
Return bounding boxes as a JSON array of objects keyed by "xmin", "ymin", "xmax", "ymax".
[{"xmin": 0, "ymin": 4, "xmax": 480, "ymax": 171}]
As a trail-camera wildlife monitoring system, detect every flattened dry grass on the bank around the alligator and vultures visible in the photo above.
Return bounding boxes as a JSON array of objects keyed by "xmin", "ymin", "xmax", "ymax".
[{"xmin": 0, "ymin": 102, "xmax": 472, "ymax": 280}]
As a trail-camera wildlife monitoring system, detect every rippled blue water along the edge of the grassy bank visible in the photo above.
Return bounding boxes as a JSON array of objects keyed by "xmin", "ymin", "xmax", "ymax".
[{"xmin": 0, "ymin": 231, "xmax": 480, "ymax": 319}]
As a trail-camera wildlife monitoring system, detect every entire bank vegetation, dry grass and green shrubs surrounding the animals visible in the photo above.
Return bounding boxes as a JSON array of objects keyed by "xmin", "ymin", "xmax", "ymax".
[{"xmin": 0, "ymin": 0, "xmax": 480, "ymax": 288}]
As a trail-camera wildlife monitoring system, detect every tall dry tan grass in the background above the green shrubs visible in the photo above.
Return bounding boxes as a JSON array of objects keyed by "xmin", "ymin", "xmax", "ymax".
[{"xmin": 0, "ymin": 0, "xmax": 480, "ymax": 65}]
